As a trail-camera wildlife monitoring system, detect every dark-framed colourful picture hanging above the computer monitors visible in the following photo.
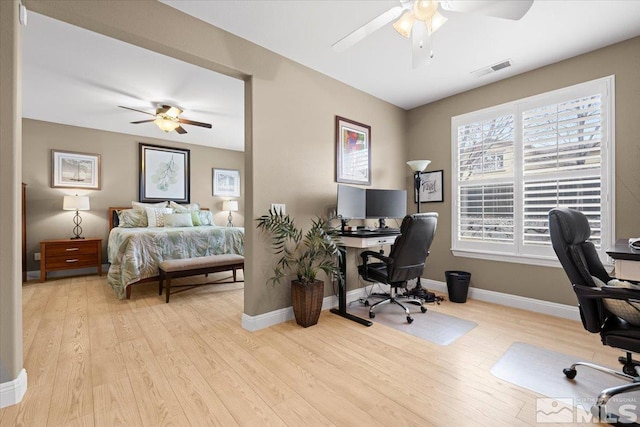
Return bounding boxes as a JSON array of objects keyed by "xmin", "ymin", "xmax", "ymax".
[{"xmin": 336, "ymin": 116, "xmax": 371, "ymax": 185}]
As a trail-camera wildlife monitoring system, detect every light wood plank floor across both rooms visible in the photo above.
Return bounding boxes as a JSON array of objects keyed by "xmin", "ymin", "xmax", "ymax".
[{"xmin": 0, "ymin": 276, "xmax": 619, "ymax": 427}]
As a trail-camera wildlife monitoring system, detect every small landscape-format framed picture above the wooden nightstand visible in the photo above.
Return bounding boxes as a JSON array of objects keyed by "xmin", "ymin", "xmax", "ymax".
[{"xmin": 51, "ymin": 150, "xmax": 100, "ymax": 190}]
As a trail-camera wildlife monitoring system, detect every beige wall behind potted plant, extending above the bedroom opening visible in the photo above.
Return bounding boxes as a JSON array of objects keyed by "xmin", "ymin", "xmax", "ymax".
[{"xmin": 20, "ymin": 0, "xmax": 408, "ymax": 315}]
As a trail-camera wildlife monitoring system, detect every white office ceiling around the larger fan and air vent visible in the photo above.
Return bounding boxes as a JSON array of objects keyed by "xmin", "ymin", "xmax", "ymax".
[{"xmin": 163, "ymin": 0, "xmax": 640, "ymax": 109}]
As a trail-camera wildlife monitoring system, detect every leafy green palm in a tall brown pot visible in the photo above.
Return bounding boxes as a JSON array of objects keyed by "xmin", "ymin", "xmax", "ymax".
[{"xmin": 256, "ymin": 209, "xmax": 341, "ymax": 328}]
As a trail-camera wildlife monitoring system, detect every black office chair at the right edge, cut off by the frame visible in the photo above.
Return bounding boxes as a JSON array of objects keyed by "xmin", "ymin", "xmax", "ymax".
[{"xmin": 549, "ymin": 208, "xmax": 640, "ymax": 421}]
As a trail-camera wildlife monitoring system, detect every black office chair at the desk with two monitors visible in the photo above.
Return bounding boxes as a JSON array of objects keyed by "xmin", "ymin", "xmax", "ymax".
[{"xmin": 358, "ymin": 212, "xmax": 438, "ymax": 323}]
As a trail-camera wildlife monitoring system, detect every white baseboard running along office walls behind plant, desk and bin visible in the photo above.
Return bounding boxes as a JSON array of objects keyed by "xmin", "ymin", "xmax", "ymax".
[{"xmin": 242, "ymin": 278, "xmax": 580, "ymax": 332}]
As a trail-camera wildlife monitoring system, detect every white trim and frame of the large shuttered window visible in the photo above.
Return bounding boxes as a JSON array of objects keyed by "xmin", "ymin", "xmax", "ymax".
[{"xmin": 450, "ymin": 75, "xmax": 615, "ymax": 268}]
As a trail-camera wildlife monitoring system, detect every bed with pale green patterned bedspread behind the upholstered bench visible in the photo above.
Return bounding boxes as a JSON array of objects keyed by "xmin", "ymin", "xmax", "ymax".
[{"xmin": 107, "ymin": 207, "xmax": 244, "ymax": 299}]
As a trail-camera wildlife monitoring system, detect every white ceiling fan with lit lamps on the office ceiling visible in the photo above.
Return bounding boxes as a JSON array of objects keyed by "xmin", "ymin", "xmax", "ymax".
[{"xmin": 331, "ymin": 0, "xmax": 533, "ymax": 68}]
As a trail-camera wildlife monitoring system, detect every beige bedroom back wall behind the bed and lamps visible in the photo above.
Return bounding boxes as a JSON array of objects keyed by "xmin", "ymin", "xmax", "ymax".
[{"xmin": 22, "ymin": 119, "xmax": 244, "ymax": 271}]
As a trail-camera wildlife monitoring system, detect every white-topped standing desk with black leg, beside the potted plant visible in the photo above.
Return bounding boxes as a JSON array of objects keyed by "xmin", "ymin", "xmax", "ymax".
[{"xmin": 331, "ymin": 231, "xmax": 400, "ymax": 326}]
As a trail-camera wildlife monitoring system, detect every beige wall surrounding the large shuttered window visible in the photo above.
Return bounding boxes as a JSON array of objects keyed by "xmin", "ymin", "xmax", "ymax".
[{"xmin": 409, "ymin": 37, "xmax": 640, "ymax": 305}]
